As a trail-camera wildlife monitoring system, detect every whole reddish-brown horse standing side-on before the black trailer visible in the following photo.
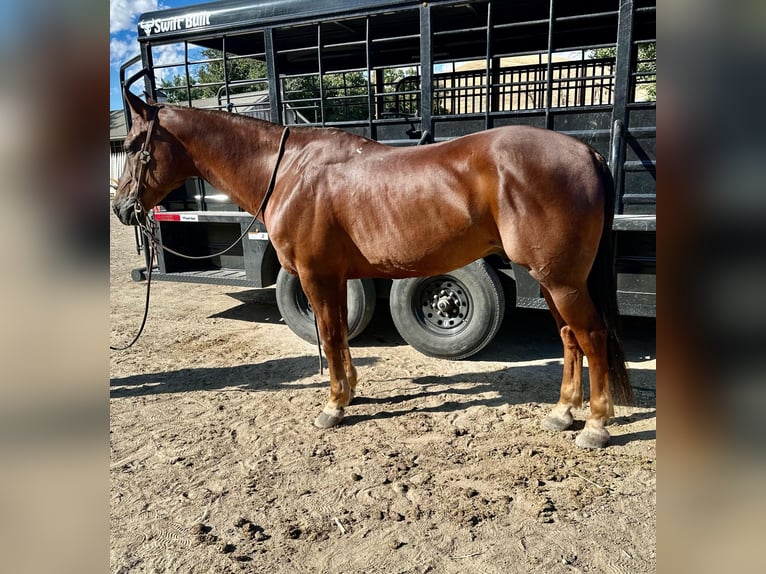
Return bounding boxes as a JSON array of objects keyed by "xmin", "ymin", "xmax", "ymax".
[{"xmin": 113, "ymin": 93, "xmax": 631, "ymax": 448}]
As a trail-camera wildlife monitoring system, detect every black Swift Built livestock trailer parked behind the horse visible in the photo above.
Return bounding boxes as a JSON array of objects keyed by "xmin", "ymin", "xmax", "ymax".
[{"xmin": 121, "ymin": 0, "xmax": 656, "ymax": 357}]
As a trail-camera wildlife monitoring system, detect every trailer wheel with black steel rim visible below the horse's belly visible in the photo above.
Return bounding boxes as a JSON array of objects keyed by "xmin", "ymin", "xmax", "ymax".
[{"xmin": 390, "ymin": 260, "xmax": 505, "ymax": 359}]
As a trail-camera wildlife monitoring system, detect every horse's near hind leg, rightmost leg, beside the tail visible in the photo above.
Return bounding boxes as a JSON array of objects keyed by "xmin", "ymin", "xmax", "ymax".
[{"xmin": 550, "ymin": 284, "xmax": 614, "ymax": 448}]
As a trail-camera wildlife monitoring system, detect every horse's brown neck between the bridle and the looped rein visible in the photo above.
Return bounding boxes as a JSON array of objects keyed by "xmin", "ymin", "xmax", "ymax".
[{"xmin": 173, "ymin": 109, "xmax": 283, "ymax": 213}]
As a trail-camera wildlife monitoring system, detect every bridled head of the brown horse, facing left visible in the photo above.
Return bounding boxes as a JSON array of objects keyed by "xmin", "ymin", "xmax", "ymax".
[{"xmin": 112, "ymin": 90, "xmax": 190, "ymax": 225}]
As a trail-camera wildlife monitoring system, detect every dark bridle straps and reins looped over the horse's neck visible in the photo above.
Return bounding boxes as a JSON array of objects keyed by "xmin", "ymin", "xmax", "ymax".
[{"xmin": 109, "ymin": 127, "xmax": 292, "ymax": 352}]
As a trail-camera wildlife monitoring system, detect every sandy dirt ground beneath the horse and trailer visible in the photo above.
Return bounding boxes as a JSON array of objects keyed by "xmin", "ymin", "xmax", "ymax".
[{"xmin": 110, "ymin": 216, "xmax": 656, "ymax": 574}]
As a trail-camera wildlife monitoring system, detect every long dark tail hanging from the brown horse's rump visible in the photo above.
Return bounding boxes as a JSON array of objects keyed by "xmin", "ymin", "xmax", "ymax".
[{"xmin": 588, "ymin": 153, "xmax": 633, "ymax": 405}]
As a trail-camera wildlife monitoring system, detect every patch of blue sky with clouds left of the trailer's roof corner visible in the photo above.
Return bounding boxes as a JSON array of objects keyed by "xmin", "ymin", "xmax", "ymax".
[{"xmin": 109, "ymin": 0, "xmax": 202, "ymax": 110}]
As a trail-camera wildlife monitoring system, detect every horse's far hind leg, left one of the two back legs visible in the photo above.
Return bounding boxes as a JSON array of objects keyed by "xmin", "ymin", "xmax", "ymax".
[{"xmin": 540, "ymin": 287, "xmax": 583, "ymax": 432}]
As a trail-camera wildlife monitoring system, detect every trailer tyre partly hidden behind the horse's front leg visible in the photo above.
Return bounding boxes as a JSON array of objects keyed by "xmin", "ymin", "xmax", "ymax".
[{"xmin": 277, "ymin": 269, "xmax": 375, "ymax": 344}]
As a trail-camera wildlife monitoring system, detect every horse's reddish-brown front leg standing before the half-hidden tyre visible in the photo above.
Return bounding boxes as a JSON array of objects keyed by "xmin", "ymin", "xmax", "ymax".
[{"xmin": 301, "ymin": 276, "xmax": 356, "ymax": 428}]
